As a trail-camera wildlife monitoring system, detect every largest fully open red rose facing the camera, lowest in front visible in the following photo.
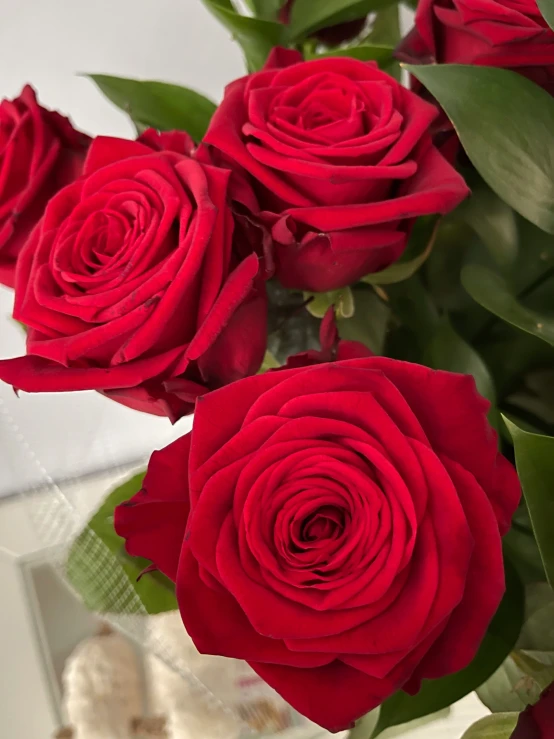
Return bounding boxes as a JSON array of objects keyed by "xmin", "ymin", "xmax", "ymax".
[{"xmin": 115, "ymin": 357, "xmax": 520, "ymax": 730}]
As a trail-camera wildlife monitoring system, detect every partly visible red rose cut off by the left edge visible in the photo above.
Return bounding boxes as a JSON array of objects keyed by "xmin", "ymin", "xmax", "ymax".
[{"xmin": 0, "ymin": 85, "xmax": 90, "ymax": 287}]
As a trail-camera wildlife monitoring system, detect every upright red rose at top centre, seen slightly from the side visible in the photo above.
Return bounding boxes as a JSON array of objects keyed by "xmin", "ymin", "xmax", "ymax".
[{"xmin": 204, "ymin": 49, "xmax": 468, "ymax": 292}]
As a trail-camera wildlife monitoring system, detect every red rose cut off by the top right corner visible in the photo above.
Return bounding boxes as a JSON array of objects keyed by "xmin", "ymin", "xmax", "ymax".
[{"xmin": 396, "ymin": 0, "xmax": 554, "ymax": 94}]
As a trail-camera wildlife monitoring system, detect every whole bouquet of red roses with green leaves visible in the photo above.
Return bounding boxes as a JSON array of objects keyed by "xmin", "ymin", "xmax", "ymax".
[{"xmin": 0, "ymin": 0, "xmax": 554, "ymax": 739}]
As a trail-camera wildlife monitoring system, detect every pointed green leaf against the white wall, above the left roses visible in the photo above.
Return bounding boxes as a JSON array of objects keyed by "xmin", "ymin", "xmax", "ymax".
[{"xmin": 88, "ymin": 74, "xmax": 216, "ymax": 141}]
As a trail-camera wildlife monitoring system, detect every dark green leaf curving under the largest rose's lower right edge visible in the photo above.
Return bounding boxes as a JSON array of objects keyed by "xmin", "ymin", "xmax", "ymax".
[{"xmin": 373, "ymin": 567, "xmax": 524, "ymax": 737}]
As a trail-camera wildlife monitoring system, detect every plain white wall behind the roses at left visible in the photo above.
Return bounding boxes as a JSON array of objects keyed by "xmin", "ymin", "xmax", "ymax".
[{"xmin": 0, "ymin": 0, "xmax": 243, "ymax": 495}]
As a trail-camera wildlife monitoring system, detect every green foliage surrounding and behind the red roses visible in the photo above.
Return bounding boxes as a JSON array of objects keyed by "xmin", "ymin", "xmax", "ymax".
[{"xmin": 63, "ymin": 0, "xmax": 554, "ymax": 739}]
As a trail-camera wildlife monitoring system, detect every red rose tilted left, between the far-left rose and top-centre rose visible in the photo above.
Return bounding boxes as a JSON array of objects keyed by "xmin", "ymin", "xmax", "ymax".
[{"xmin": 0, "ymin": 131, "xmax": 266, "ymax": 419}]
